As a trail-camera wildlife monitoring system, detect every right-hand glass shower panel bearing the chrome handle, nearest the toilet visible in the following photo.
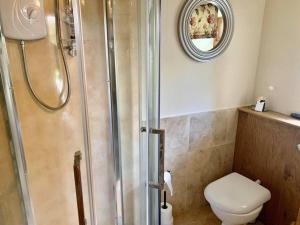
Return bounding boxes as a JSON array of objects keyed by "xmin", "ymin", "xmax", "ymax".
[{"xmin": 106, "ymin": 0, "xmax": 162, "ymax": 225}]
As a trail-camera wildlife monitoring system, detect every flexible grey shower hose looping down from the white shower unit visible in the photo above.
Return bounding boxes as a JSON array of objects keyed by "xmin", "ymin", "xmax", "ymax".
[{"xmin": 20, "ymin": 0, "xmax": 71, "ymax": 111}]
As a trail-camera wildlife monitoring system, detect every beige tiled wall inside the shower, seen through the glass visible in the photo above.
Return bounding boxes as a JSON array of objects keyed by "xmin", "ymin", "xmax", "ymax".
[{"xmin": 2, "ymin": 0, "xmax": 139, "ymax": 225}]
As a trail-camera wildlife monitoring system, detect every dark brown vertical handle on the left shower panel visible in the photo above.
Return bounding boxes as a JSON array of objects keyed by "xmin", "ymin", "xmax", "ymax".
[{"xmin": 73, "ymin": 151, "xmax": 86, "ymax": 225}]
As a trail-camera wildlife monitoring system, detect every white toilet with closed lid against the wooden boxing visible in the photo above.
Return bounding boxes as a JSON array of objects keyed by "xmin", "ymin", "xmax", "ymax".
[{"xmin": 204, "ymin": 173, "xmax": 271, "ymax": 225}]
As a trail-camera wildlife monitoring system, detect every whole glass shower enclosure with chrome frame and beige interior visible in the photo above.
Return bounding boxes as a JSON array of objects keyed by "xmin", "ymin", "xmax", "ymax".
[{"xmin": 0, "ymin": 0, "xmax": 164, "ymax": 225}]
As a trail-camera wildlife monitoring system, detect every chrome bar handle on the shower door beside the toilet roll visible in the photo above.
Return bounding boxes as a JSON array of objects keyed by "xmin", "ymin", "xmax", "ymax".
[{"xmin": 149, "ymin": 129, "xmax": 165, "ymax": 190}]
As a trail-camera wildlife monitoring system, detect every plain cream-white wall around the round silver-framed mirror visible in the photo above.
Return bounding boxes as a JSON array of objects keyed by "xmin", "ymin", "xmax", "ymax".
[{"xmin": 161, "ymin": 0, "xmax": 265, "ymax": 117}]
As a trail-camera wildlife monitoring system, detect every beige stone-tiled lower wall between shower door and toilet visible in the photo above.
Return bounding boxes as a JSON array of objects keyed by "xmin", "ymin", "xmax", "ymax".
[{"xmin": 161, "ymin": 109, "xmax": 237, "ymax": 215}]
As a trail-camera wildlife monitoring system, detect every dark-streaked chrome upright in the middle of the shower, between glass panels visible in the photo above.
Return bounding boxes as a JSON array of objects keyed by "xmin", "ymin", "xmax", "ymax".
[{"xmin": 103, "ymin": 0, "xmax": 124, "ymax": 225}]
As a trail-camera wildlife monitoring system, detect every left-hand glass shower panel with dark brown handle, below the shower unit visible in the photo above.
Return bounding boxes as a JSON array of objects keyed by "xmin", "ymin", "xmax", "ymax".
[{"xmin": 0, "ymin": 1, "xmax": 96, "ymax": 225}]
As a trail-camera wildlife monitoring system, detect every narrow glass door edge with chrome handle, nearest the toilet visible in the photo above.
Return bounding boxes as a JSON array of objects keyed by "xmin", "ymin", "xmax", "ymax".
[{"xmin": 140, "ymin": 0, "xmax": 165, "ymax": 225}]
